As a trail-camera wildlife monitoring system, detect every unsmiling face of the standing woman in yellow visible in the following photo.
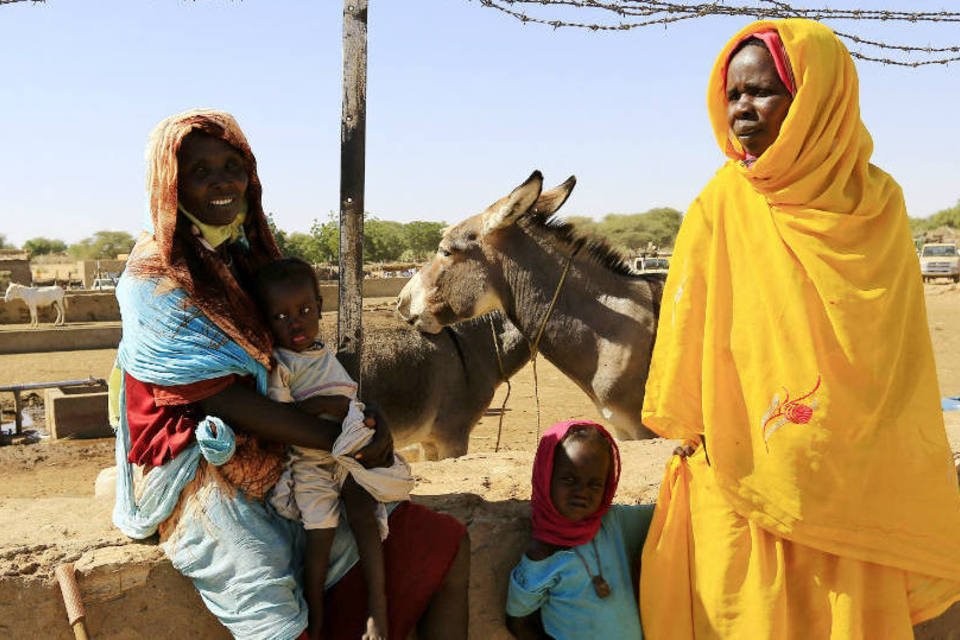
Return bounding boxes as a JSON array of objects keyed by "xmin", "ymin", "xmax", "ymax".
[{"xmin": 726, "ymin": 44, "xmax": 793, "ymax": 157}]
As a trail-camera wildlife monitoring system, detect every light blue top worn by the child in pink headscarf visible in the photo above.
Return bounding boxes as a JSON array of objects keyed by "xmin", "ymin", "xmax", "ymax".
[{"xmin": 507, "ymin": 504, "xmax": 653, "ymax": 640}]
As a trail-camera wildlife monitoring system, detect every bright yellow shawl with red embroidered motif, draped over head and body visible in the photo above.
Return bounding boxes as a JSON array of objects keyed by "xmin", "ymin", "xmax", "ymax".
[{"xmin": 643, "ymin": 19, "xmax": 960, "ymax": 578}]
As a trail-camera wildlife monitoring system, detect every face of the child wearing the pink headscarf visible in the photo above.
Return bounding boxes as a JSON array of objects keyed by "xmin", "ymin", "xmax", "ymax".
[{"xmin": 550, "ymin": 438, "xmax": 610, "ymax": 521}]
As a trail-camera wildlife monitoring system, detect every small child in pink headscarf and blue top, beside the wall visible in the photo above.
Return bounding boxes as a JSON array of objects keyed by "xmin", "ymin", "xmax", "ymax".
[{"xmin": 507, "ymin": 420, "xmax": 653, "ymax": 640}]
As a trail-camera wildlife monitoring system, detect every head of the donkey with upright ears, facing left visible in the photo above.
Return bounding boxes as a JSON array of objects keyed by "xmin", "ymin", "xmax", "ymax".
[{"xmin": 397, "ymin": 171, "xmax": 576, "ymax": 333}]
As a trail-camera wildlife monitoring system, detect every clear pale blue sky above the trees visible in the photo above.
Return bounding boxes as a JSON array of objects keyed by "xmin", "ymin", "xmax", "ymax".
[{"xmin": 0, "ymin": 0, "xmax": 960, "ymax": 244}]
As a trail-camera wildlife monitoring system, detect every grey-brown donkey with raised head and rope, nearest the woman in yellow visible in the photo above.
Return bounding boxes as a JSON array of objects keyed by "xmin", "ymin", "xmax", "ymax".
[{"xmin": 397, "ymin": 171, "xmax": 664, "ymax": 439}]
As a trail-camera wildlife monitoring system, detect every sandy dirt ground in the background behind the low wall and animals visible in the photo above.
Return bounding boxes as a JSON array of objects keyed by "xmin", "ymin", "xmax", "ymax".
[{"xmin": 0, "ymin": 284, "xmax": 960, "ymax": 504}]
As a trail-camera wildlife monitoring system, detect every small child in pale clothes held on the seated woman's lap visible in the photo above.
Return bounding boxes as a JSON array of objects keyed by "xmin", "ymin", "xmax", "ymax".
[{"xmin": 254, "ymin": 258, "xmax": 413, "ymax": 640}]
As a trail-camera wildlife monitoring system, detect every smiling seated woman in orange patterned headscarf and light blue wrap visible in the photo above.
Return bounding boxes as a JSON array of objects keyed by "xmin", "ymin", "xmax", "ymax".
[{"xmin": 110, "ymin": 109, "xmax": 470, "ymax": 640}]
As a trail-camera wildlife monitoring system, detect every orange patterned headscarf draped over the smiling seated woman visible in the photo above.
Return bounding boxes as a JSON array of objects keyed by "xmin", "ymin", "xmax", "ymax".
[{"xmin": 128, "ymin": 109, "xmax": 280, "ymax": 367}]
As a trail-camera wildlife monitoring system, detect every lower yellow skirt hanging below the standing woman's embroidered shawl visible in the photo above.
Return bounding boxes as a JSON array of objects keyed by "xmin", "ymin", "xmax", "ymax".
[{"xmin": 640, "ymin": 449, "xmax": 958, "ymax": 640}]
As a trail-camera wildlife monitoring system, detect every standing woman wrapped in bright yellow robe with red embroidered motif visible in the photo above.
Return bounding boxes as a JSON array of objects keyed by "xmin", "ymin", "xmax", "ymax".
[{"xmin": 640, "ymin": 19, "xmax": 960, "ymax": 640}]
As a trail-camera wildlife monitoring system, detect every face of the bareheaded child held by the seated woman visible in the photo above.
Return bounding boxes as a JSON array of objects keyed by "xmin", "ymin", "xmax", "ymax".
[{"xmin": 263, "ymin": 280, "xmax": 320, "ymax": 351}]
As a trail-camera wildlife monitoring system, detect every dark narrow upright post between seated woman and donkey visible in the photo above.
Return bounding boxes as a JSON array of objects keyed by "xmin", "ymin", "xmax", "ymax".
[{"xmin": 337, "ymin": 0, "xmax": 367, "ymax": 384}]
